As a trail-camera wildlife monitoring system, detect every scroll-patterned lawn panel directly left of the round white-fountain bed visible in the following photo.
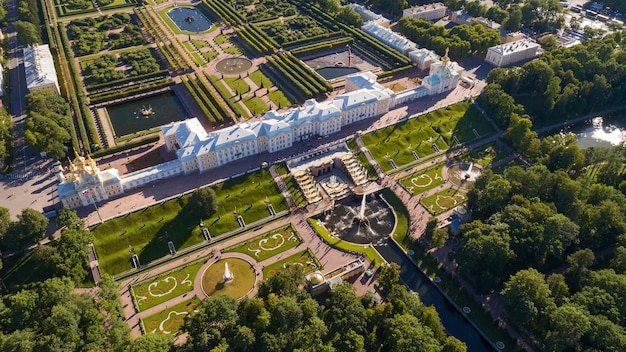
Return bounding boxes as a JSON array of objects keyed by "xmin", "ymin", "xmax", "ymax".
[{"xmin": 132, "ymin": 259, "xmax": 206, "ymax": 312}]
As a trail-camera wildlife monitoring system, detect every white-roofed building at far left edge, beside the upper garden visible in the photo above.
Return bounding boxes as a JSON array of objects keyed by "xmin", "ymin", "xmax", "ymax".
[{"xmin": 23, "ymin": 44, "xmax": 60, "ymax": 94}]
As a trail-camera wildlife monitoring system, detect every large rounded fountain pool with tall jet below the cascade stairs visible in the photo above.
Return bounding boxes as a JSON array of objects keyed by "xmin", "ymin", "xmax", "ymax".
[{"xmin": 318, "ymin": 192, "xmax": 395, "ymax": 244}]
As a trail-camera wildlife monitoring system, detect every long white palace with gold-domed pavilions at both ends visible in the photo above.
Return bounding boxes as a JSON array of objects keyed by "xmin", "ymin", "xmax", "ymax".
[{"xmin": 58, "ymin": 69, "xmax": 460, "ymax": 208}]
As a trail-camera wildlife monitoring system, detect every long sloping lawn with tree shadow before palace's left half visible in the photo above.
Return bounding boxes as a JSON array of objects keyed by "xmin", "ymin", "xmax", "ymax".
[{"xmin": 91, "ymin": 170, "xmax": 289, "ymax": 275}]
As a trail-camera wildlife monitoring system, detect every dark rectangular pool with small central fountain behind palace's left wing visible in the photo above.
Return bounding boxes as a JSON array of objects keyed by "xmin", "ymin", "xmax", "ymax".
[{"xmin": 106, "ymin": 92, "xmax": 189, "ymax": 137}]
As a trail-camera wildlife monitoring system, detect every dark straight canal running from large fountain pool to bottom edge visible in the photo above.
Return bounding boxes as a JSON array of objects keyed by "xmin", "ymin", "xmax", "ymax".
[{"xmin": 375, "ymin": 240, "xmax": 494, "ymax": 352}]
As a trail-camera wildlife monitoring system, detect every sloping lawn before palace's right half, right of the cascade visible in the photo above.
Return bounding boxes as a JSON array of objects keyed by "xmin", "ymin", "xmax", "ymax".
[{"xmin": 361, "ymin": 102, "xmax": 494, "ymax": 171}]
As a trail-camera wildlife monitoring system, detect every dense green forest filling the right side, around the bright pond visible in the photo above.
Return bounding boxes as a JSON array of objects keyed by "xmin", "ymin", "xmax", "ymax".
[{"xmin": 464, "ymin": 29, "xmax": 626, "ymax": 351}]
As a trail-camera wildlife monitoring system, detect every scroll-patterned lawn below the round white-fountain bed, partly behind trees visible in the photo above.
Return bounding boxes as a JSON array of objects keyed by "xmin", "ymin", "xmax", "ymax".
[{"xmin": 141, "ymin": 296, "xmax": 201, "ymax": 335}]
